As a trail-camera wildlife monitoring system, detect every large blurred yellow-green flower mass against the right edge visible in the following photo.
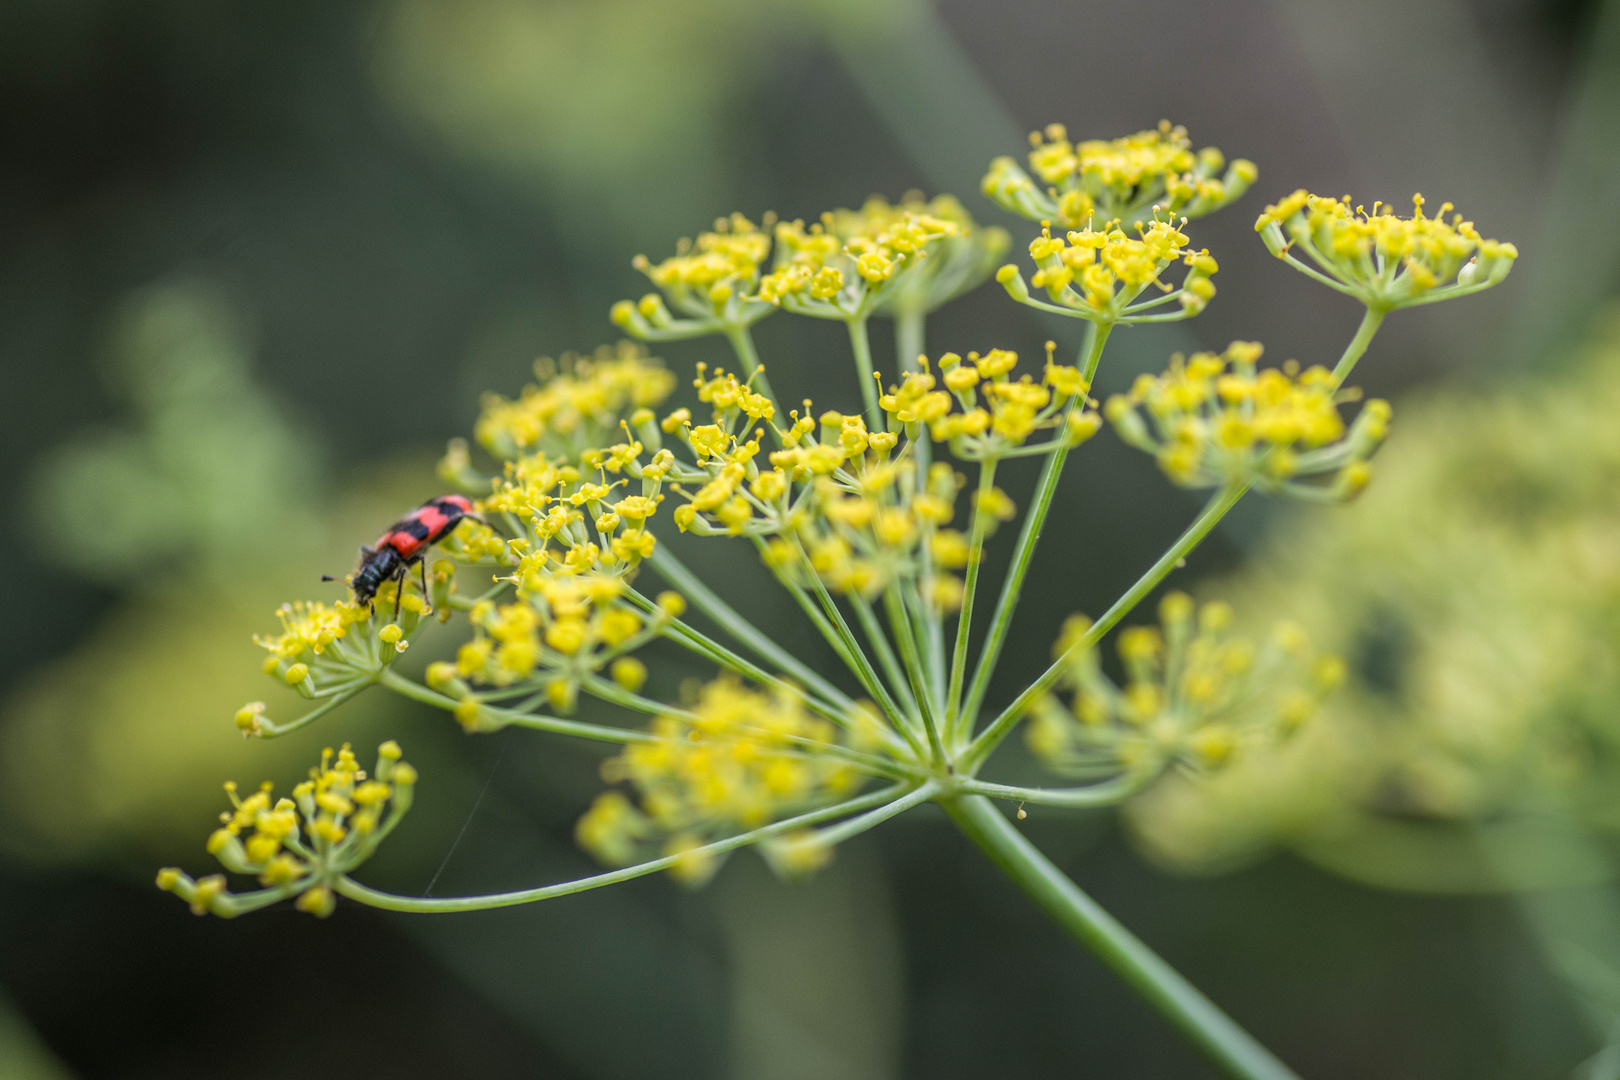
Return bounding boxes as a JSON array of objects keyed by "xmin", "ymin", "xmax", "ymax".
[{"xmin": 1131, "ymin": 319, "xmax": 1620, "ymax": 892}]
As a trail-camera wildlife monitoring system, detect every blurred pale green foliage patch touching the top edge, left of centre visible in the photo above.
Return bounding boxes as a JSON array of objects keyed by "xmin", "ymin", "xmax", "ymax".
[{"xmin": 373, "ymin": 0, "xmax": 912, "ymax": 239}]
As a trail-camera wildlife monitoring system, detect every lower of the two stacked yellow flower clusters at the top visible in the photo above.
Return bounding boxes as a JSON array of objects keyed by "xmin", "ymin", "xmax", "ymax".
[{"xmin": 996, "ymin": 217, "xmax": 1220, "ymax": 324}]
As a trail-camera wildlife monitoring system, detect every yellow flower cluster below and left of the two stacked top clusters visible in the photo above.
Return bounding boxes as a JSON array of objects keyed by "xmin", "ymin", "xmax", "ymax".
[{"xmin": 878, "ymin": 342, "xmax": 1102, "ymax": 461}]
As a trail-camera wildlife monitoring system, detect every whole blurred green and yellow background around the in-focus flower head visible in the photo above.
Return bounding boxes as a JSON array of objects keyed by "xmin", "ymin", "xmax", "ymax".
[{"xmin": 0, "ymin": 0, "xmax": 1620, "ymax": 1080}]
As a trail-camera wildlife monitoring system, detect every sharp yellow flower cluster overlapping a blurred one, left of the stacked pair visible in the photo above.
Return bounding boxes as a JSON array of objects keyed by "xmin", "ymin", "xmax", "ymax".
[{"xmin": 758, "ymin": 199, "xmax": 966, "ymax": 319}]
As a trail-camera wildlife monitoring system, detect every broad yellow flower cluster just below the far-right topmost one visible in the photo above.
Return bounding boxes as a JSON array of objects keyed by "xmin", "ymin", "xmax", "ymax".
[{"xmin": 1103, "ymin": 342, "xmax": 1390, "ymax": 499}]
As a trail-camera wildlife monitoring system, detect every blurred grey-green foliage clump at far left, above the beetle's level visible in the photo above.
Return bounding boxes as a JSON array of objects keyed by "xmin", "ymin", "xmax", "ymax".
[{"xmin": 34, "ymin": 280, "xmax": 321, "ymax": 585}]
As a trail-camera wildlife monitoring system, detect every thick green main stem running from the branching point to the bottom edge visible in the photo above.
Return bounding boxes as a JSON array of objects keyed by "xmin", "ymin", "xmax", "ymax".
[{"xmin": 944, "ymin": 795, "xmax": 1298, "ymax": 1080}]
